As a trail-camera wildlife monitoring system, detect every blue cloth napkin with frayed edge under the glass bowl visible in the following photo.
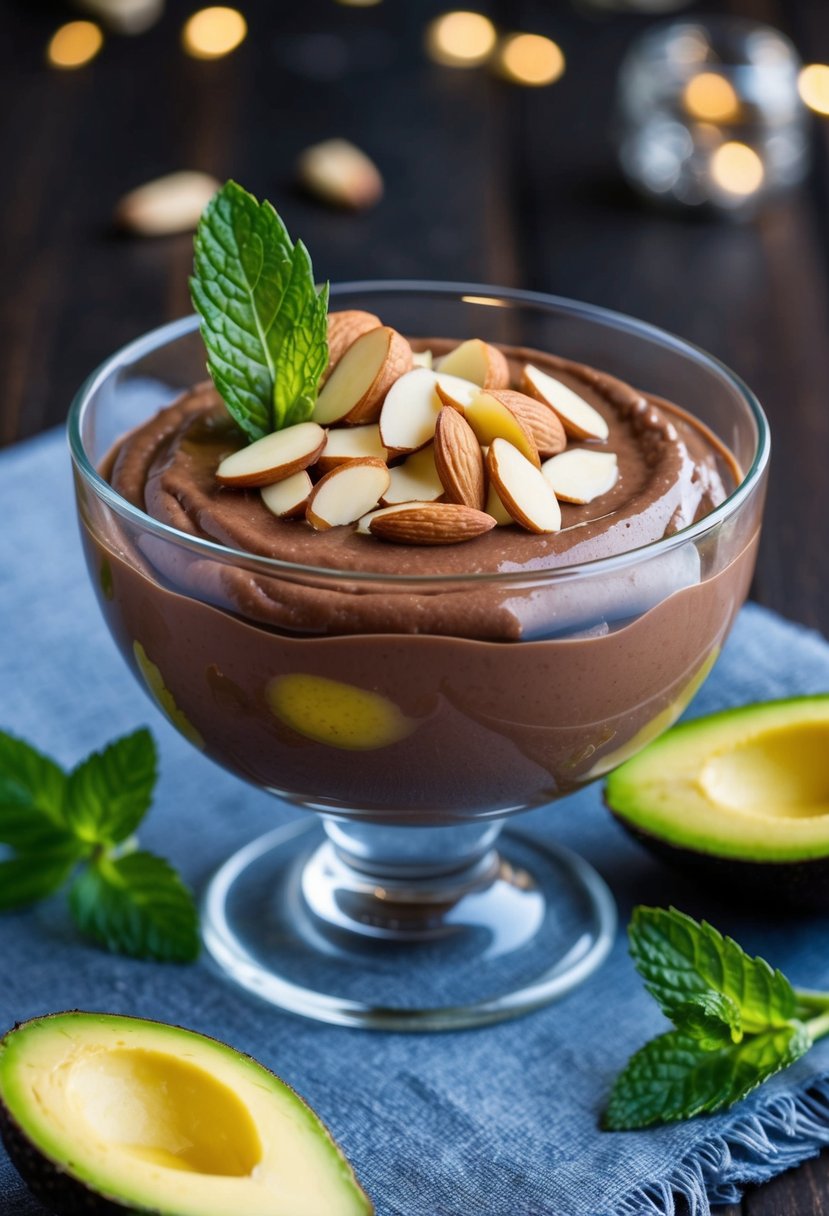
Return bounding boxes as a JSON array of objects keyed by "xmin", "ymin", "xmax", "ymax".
[{"xmin": 0, "ymin": 433, "xmax": 829, "ymax": 1216}]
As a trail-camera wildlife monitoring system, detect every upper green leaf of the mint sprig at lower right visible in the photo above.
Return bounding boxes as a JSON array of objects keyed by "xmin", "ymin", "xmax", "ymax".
[{"xmin": 628, "ymin": 907, "xmax": 797, "ymax": 1034}]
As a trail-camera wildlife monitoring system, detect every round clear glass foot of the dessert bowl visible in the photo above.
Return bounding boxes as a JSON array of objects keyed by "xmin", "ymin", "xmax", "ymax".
[{"xmin": 203, "ymin": 820, "xmax": 616, "ymax": 1031}]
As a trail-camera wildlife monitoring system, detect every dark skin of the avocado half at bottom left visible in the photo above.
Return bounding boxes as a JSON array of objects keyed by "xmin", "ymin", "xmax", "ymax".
[{"xmin": 0, "ymin": 1009, "xmax": 374, "ymax": 1216}]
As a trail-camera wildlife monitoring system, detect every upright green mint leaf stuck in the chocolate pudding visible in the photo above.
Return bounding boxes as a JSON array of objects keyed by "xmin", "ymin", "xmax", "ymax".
[{"xmin": 190, "ymin": 181, "xmax": 328, "ymax": 440}]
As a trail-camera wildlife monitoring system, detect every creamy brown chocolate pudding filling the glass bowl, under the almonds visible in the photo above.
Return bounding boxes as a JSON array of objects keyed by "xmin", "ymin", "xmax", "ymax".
[{"xmin": 84, "ymin": 340, "xmax": 762, "ymax": 823}]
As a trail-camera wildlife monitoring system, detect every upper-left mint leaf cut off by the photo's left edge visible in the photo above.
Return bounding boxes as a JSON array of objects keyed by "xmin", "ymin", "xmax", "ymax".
[{"xmin": 0, "ymin": 731, "xmax": 73, "ymax": 852}]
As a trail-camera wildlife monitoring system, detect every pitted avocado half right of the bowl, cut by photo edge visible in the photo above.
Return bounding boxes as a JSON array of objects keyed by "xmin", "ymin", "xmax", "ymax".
[{"xmin": 605, "ymin": 696, "xmax": 829, "ymax": 912}]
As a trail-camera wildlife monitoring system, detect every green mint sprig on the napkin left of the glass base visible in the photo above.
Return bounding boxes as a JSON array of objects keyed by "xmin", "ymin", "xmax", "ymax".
[{"xmin": 0, "ymin": 730, "xmax": 199, "ymax": 962}]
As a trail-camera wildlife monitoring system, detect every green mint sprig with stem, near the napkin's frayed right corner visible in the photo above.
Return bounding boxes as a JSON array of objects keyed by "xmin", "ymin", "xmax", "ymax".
[{"xmin": 604, "ymin": 907, "xmax": 829, "ymax": 1131}]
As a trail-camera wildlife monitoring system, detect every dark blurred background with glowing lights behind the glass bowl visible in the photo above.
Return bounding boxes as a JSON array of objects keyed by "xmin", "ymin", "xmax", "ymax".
[{"xmin": 0, "ymin": 0, "xmax": 829, "ymax": 646}]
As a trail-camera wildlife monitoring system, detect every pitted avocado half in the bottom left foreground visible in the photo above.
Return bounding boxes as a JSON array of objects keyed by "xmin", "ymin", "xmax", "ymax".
[{"xmin": 0, "ymin": 1010, "xmax": 373, "ymax": 1216}]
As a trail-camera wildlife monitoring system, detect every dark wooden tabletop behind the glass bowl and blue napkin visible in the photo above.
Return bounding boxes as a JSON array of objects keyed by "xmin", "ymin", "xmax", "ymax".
[{"xmin": 0, "ymin": 0, "xmax": 829, "ymax": 1216}]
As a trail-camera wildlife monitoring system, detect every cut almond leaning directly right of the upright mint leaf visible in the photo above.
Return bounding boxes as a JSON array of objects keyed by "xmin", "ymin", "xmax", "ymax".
[{"xmin": 314, "ymin": 325, "xmax": 412, "ymax": 426}]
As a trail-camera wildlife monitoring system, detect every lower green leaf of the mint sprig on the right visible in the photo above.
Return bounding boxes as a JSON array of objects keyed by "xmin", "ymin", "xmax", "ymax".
[{"xmin": 604, "ymin": 1023, "xmax": 812, "ymax": 1131}]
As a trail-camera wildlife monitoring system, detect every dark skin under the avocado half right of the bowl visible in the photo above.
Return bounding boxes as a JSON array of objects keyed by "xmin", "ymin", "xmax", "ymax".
[{"xmin": 605, "ymin": 817, "xmax": 829, "ymax": 912}]
